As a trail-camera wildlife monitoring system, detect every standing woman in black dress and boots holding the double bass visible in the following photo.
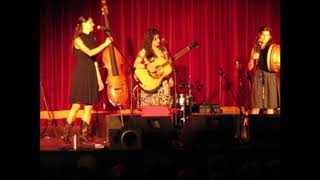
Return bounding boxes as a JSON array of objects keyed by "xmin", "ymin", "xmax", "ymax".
[{"xmin": 62, "ymin": 16, "xmax": 111, "ymax": 143}]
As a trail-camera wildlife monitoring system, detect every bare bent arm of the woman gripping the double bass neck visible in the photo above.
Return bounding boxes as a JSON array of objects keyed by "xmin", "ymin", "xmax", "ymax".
[{"xmin": 74, "ymin": 37, "xmax": 112, "ymax": 57}]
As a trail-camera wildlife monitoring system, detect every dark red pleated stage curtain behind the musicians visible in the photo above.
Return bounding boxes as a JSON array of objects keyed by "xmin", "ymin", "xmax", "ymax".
[{"xmin": 40, "ymin": 0, "xmax": 280, "ymax": 110}]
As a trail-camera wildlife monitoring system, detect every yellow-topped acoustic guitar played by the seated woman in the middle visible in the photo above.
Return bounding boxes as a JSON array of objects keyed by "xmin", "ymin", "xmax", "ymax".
[{"xmin": 134, "ymin": 42, "xmax": 199, "ymax": 92}]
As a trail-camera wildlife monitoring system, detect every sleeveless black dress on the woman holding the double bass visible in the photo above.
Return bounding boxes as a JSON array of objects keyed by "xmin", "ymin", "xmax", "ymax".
[{"xmin": 70, "ymin": 33, "xmax": 99, "ymax": 105}]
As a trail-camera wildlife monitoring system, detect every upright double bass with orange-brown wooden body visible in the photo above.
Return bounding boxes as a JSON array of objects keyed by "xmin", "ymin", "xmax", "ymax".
[{"xmin": 101, "ymin": 0, "xmax": 128, "ymax": 106}]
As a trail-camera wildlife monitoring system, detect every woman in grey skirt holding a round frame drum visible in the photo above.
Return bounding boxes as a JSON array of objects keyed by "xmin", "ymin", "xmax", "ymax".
[{"xmin": 248, "ymin": 26, "xmax": 280, "ymax": 114}]
